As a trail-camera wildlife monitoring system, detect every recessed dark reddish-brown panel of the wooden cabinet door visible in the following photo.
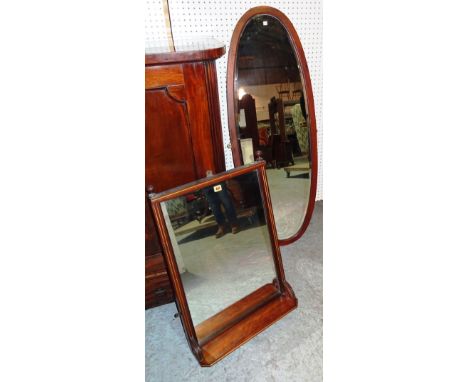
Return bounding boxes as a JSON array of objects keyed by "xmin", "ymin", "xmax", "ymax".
[{"xmin": 145, "ymin": 87, "xmax": 197, "ymax": 192}]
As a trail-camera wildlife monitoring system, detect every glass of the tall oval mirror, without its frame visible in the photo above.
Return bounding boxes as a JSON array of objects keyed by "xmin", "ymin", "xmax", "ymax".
[{"xmin": 231, "ymin": 14, "xmax": 315, "ymax": 240}]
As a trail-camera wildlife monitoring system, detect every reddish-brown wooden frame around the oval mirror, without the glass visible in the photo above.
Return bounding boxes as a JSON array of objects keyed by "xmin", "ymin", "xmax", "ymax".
[{"xmin": 226, "ymin": 6, "xmax": 318, "ymax": 245}]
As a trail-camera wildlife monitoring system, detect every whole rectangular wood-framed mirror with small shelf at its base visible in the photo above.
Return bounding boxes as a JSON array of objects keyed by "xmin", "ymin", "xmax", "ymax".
[{"xmin": 149, "ymin": 161, "xmax": 297, "ymax": 366}]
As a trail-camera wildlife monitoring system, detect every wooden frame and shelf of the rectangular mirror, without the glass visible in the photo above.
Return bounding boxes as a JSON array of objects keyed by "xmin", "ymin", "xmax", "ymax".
[{"xmin": 149, "ymin": 161, "xmax": 297, "ymax": 366}]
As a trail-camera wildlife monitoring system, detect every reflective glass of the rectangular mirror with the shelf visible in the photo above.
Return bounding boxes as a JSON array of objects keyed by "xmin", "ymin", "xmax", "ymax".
[{"xmin": 162, "ymin": 172, "xmax": 278, "ymax": 332}]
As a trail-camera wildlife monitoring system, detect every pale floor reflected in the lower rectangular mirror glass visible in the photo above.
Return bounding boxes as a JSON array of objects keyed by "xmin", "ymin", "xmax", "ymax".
[{"xmin": 179, "ymin": 223, "xmax": 276, "ymax": 326}]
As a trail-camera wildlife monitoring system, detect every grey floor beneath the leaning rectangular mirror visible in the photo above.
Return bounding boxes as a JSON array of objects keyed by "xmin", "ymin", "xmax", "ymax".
[{"xmin": 146, "ymin": 202, "xmax": 323, "ymax": 382}]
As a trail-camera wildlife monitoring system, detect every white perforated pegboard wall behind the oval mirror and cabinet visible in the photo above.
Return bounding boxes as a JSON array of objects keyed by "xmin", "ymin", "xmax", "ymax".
[{"xmin": 145, "ymin": 0, "xmax": 323, "ymax": 200}]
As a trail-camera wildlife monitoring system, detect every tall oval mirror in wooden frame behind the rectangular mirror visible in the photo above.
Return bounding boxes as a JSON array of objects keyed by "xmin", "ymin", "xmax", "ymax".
[{"xmin": 227, "ymin": 7, "xmax": 317, "ymax": 245}]
